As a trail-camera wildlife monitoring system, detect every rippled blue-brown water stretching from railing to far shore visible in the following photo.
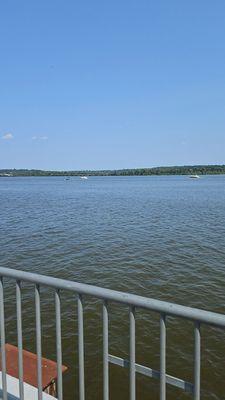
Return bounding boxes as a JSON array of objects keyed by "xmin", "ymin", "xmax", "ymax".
[{"xmin": 0, "ymin": 176, "xmax": 225, "ymax": 400}]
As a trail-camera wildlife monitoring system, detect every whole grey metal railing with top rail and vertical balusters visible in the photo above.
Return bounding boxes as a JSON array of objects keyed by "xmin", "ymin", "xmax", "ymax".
[{"xmin": 0, "ymin": 268, "xmax": 225, "ymax": 400}]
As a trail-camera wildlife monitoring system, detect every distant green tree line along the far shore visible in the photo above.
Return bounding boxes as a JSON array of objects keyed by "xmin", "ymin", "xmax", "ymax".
[{"xmin": 0, "ymin": 165, "xmax": 225, "ymax": 176}]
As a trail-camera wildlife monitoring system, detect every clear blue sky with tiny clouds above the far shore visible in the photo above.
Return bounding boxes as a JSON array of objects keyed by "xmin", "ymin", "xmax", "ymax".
[{"xmin": 0, "ymin": 0, "xmax": 225, "ymax": 169}]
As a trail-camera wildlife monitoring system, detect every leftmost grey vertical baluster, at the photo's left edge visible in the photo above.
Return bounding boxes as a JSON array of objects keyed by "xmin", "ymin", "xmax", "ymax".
[{"xmin": 0, "ymin": 277, "xmax": 7, "ymax": 400}]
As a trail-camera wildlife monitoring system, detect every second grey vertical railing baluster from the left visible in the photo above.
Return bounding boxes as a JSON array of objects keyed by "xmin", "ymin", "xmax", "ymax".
[{"xmin": 16, "ymin": 281, "xmax": 24, "ymax": 400}]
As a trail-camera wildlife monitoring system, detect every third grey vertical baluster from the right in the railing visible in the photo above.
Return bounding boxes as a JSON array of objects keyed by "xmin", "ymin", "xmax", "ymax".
[{"xmin": 129, "ymin": 306, "xmax": 136, "ymax": 400}]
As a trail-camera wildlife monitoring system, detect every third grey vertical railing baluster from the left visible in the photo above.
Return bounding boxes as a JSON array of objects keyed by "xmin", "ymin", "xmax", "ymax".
[{"xmin": 35, "ymin": 285, "xmax": 42, "ymax": 400}]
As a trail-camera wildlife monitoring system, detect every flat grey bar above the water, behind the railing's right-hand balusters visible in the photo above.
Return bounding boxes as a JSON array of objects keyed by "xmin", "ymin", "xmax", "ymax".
[{"xmin": 109, "ymin": 354, "xmax": 194, "ymax": 394}]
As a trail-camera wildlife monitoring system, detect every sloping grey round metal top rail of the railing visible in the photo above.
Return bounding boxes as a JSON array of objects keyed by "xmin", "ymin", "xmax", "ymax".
[{"xmin": 0, "ymin": 267, "xmax": 225, "ymax": 328}]
